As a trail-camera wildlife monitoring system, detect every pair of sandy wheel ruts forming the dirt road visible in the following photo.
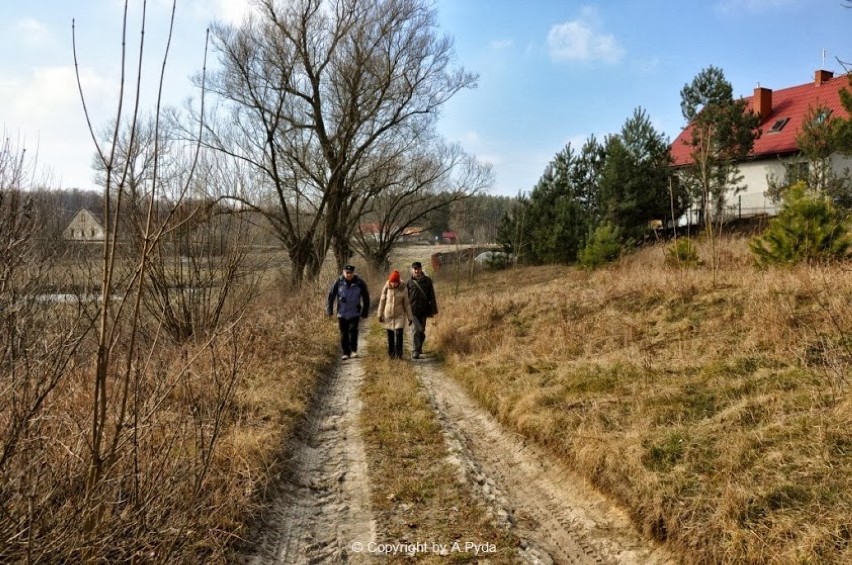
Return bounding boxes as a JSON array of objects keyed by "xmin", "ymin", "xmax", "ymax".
[{"xmin": 245, "ymin": 345, "xmax": 674, "ymax": 564}]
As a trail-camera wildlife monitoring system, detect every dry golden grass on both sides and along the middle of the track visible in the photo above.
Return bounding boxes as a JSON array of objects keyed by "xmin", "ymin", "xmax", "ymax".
[{"xmin": 8, "ymin": 234, "xmax": 852, "ymax": 563}]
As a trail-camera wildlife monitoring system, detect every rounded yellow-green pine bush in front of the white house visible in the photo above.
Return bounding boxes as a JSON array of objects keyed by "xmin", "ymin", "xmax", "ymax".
[{"xmin": 749, "ymin": 183, "xmax": 852, "ymax": 265}]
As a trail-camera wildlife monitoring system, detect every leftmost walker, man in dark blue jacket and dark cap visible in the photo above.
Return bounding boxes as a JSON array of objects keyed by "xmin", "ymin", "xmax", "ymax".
[{"xmin": 325, "ymin": 265, "xmax": 370, "ymax": 361}]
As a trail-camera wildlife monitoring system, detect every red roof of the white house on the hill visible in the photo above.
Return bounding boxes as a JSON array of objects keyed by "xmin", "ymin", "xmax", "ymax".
[{"xmin": 671, "ymin": 71, "xmax": 852, "ymax": 166}]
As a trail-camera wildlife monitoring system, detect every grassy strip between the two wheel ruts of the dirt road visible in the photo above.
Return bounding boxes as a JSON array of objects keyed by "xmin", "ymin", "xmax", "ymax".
[{"xmin": 361, "ymin": 324, "xmax": 518, "ymax": 563}]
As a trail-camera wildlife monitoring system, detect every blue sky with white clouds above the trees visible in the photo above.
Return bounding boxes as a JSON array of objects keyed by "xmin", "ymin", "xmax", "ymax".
[{"xmin": 0, "ymin": 0, "xmax": 852, "ymax": 196}]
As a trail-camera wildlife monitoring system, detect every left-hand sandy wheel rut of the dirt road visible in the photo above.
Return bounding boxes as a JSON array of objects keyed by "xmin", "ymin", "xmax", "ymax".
[{"xmin": 240, "ymin": 333, "xmax": 376, "ymax": 565}]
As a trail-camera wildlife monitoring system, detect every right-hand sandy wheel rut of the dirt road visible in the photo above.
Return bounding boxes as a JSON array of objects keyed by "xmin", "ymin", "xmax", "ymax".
[{"xmin": 416, "ymin": 359, "xmax": 676, "ymax": 564}]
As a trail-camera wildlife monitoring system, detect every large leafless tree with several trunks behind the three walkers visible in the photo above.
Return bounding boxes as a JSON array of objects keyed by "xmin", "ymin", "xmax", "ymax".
[{"xmin": 202, "ymin": 0, "xmax": 476, "ymax": 284}]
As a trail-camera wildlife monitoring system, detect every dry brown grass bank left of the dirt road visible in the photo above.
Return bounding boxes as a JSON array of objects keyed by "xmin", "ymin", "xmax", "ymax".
[{"xmin": 0, "ymin": 283, "xmax": 337, "ymax": 563}]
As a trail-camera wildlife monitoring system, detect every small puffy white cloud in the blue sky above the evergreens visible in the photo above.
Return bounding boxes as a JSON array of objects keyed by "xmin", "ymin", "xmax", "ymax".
[{"xmin": 547, "ymin": 8, "xmax": 624, "ymax": 64}]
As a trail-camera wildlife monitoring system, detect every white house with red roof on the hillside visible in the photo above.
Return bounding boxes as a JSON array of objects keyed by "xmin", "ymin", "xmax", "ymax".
[{"xmin": 671, "ymin": 70, "xmax": 852, "ymax": 217}]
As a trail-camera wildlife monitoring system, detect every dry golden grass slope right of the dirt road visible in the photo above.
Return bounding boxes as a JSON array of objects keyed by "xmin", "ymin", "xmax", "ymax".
[{"xmin": 433, "ymin": 239, "xmax": 852, "ymax": 563}]
